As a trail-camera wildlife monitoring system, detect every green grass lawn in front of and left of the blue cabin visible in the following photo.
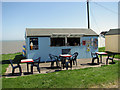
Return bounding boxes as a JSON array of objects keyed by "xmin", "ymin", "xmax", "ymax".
[{"xmin": 2, "ymin": 47, "xmax": 118, "ymax": 88}]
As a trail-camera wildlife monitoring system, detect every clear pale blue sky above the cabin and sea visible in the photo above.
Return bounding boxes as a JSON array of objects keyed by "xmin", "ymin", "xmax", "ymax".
[{"xmin": 2, "ymin": 1, "xmax": 118, "ymax": 40}]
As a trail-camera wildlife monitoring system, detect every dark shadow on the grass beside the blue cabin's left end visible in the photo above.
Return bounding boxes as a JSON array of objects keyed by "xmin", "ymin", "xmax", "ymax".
[{"xmin": 0, "ymin": 54, "xmax": 25, "ymax": 64}]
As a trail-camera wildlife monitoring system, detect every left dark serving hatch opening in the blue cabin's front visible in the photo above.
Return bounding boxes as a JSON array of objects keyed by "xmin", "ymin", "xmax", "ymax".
[{"xmin": 51, "ymin": 38, "xmax": 65, "ymax": 46}]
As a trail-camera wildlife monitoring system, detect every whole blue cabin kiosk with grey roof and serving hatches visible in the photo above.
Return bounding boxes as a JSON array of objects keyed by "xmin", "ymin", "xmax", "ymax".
[{"xmin": 25, "ymin": 28, "xmax": 98, "ymax": 62}]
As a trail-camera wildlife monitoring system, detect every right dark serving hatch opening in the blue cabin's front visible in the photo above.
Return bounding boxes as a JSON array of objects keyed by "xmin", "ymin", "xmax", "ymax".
[{"xmin": 67, "ymin": 38, "xmax": 80, "ymax": 46}]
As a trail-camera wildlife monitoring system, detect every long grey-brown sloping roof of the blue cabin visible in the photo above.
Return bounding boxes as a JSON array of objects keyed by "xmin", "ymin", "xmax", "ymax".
[{"xmin": 26, "ymin": 28, "xmax": 98, "ymax": 37}]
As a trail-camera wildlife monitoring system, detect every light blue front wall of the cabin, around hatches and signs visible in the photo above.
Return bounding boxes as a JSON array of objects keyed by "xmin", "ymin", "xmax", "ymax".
[{"xmin": 26, "ymin": 36, "xmax": 98, "ymax": 61}]
